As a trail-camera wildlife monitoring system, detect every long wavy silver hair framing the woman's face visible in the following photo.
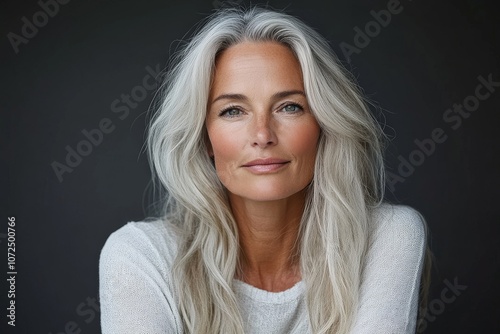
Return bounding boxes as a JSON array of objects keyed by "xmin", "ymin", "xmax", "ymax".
[{"xmin": 148, "ymin": 7, "xmax": 384, "ymax": 333}]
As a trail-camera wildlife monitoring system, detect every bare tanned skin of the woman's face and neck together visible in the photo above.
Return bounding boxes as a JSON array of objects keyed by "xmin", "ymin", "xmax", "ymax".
[{"xmin": 206, "ymin": 42, "xmax": 320, "ymax": 292}]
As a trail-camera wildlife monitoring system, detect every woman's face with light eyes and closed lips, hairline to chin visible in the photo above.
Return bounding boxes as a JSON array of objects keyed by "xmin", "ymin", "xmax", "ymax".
[{"xmin": 206, "ymin": 42, "xmax": 320, "ymax": 201}]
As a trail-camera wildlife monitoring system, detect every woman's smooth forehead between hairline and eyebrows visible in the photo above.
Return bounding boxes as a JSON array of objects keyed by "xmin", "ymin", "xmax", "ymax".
[{"xmin": 212, "ymin": 42, "xmax": 303, "ymax": 93}]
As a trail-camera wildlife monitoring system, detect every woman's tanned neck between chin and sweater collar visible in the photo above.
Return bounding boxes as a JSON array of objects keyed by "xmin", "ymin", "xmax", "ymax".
[{"xmin": 229, "ymin": 190, "xmax": 306, "ymax": 291}]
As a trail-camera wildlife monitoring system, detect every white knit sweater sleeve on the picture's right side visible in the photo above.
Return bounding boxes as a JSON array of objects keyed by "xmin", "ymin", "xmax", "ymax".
[{"xmin": 352, "ymin": 205, "xmax": 426, "ymax": 334}]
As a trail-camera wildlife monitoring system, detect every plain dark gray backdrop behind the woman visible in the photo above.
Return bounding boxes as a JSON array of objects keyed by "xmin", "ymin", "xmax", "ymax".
[{"xmin": 0, "ymin": 0, "xmax": 500, "ymax": 334}]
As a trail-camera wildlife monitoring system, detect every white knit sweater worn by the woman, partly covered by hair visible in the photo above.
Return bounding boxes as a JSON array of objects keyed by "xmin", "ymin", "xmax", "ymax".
[{"xmin": 99, "ymin": 204, "xmax": 425, "ymax": 334}]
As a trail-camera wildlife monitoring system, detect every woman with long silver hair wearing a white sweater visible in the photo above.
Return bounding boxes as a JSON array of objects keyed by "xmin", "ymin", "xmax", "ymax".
[{"xmin": 100, "ymin": 8, "xmax": 426, "ymax": 334}]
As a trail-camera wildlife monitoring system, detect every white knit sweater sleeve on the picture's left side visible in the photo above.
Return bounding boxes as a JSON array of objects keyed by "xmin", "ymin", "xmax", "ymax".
[{"xmin": 99, "ymin": 223, "xmax": 181, "ymax": 334}]
